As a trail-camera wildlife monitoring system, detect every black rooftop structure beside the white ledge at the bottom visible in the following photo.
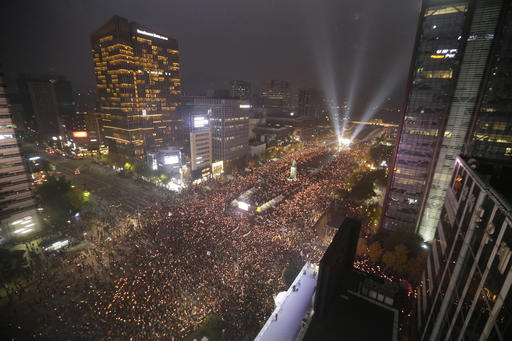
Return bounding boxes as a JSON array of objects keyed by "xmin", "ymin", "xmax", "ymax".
[{"xmin": 301, "ymin": 218, "xmax": 398, "ymax": 341}]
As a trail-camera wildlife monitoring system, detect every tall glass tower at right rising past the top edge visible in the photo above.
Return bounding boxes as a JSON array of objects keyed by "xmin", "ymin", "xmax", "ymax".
[{"xmin": 381, "ymin": 0, "xmax": 510, "ymax": 241}]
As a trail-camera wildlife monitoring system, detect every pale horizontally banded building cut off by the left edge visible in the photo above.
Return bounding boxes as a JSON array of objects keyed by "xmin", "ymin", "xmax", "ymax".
[{"xmin": 0, "ymin": 66, "xmax": 40, "ymax": 243}]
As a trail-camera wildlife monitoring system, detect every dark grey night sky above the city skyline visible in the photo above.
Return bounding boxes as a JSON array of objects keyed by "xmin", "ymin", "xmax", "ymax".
[{"xmin": 0, "ymin": 0, "xmax": 420, "ymax": 119}]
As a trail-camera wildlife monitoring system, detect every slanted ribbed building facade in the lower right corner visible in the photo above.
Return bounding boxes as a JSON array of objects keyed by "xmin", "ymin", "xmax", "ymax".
[{"xmin": 417, "ymin": 157, "xmax": 512, "ymax": 340}]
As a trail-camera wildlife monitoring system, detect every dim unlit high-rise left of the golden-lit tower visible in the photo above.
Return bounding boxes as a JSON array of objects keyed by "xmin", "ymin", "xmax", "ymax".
[{"xmin": 18, "ymin": 75, "xmax": 75, "ymax": 139}]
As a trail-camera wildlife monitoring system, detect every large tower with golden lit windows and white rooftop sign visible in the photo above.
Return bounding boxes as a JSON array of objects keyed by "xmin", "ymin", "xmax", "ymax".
[{"xmin": 91, "ymin": 16, "xmax": 182, "ymax": 157}]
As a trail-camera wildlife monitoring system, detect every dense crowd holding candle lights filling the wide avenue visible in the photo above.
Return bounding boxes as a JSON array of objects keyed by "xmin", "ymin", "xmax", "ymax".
[{"xmin": 2, "ymin": 144, "xmax": 363, "ymax": 340}]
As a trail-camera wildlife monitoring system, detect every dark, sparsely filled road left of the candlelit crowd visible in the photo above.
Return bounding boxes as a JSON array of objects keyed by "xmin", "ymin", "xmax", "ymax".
[{"xmin": 48, "ymin": 156, "xmax": 170, "ymax": 213}]
